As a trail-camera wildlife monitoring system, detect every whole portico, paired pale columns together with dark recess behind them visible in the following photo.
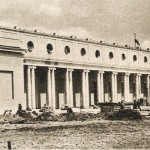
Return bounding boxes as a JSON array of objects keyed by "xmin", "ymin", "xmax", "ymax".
[{"xmin": 23, "ymin": 65, "xmax": 150, "ymax": 109}]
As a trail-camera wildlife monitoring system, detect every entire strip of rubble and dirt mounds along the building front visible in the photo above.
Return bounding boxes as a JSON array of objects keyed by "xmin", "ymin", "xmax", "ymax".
[{"xmin": 0, "ymin": 104, "xmax": 148, "ymax": 124}]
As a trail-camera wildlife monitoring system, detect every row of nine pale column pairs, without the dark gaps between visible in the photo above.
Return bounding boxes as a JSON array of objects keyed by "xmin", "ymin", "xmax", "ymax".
[{"xmin": 27, "ymin": 66, "xmax": 150, "ymax": 109}]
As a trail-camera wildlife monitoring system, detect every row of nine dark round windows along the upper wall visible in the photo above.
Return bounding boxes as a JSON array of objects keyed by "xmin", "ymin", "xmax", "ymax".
[{"xmin": 27, "ymin": 41, "xmax": 148, "ymax": 63}]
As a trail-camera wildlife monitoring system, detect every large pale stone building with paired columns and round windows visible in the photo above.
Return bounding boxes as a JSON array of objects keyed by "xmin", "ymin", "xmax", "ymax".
[{"xmin": 0, "ymin": 27, "xmax": 150, "ymax": 113}]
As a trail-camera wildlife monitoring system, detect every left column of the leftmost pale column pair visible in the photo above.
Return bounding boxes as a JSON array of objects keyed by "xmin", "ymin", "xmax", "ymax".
[{"xmin": 27, "ymin": 66, "xmax": 31, "ymax": 108}]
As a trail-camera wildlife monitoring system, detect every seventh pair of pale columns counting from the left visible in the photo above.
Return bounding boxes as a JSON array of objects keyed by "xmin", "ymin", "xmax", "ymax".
[{"xmin": 124, "ymin": 73, "xmax": 130, "ymax": 102}]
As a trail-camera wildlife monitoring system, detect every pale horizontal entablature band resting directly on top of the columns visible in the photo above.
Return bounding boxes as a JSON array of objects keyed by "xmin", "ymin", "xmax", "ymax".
[{"xmin": 24, "ymin": 58, "xmax": 150, "ymax": 74}]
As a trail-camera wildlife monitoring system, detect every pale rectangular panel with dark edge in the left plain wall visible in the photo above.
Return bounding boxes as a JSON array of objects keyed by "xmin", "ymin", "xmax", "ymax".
[{"xmin": 0, "ymin": 71, "xmax": 14, "ymax": 99}]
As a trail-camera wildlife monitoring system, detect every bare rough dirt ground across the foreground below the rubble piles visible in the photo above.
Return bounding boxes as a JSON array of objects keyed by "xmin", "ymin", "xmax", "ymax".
[{"xmin": 0, "ymin": 120, "xmax": 150, "ymax": 150}]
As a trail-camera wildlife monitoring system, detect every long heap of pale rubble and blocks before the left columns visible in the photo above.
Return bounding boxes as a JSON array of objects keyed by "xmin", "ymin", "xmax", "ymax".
[{"xmin": 10, "ymin": 104, "xmax": 101, "ymax": 124}]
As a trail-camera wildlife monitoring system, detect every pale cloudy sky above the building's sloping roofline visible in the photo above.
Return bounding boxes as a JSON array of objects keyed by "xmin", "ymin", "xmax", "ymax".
[{"xmin": 0, "ymin": 0, "xmax": 150, "ymax": 48}]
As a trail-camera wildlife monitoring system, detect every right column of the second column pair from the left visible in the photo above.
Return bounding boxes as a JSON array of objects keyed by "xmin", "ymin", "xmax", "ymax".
[{"xmin": 51, "ymin": 68, "xmax": 56, "ymax": 109}]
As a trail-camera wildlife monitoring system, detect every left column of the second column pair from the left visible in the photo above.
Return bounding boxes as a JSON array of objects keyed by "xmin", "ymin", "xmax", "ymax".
[{"xmin": 47, "ymin": 68, "xmax": 52, "ymax": 106}]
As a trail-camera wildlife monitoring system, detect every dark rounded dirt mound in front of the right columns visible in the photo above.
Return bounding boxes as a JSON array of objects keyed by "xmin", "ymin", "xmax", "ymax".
[{"xmin": 106, "ymin": 109, "xmax": 143, "ymax": 120}]
